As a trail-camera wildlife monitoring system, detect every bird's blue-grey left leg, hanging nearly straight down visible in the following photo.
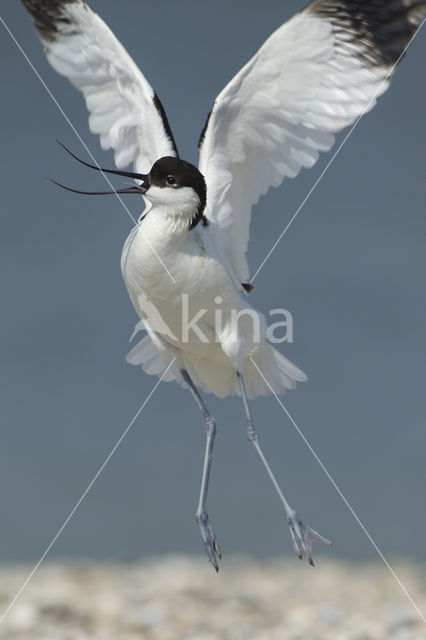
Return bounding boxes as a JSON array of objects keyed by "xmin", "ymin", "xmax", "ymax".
[{"xmin": 181, "ymin": 369, "xmax": 222, "ymax": 571}]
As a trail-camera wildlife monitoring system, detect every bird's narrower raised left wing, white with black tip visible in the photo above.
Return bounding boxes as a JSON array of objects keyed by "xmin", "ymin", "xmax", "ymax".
[{"xmin": 22, "ymin": 0, "xmax": 178, "ymax": 173}]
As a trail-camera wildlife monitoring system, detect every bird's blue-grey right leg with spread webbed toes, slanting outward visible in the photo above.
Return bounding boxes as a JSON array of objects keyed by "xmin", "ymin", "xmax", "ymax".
[{"xmin": 237, "ymin": 371, "xmax": 332, "ymax": 566}]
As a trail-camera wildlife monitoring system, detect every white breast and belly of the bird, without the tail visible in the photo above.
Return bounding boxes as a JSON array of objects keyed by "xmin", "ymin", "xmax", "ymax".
[{"xmin": 122, "ymin": 211, "xmax": 264, "ymax": 366}]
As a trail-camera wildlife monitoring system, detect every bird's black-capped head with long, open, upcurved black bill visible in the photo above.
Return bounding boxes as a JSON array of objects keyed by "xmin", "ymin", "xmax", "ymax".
[{"xmin": 53, "ymin": 145, "xmax": 207, "ymax": 229}]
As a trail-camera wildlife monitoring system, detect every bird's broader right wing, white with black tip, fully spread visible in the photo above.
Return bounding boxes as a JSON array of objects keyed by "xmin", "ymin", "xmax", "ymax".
[{"xmin": 199, "ymin": 0, "xmax": 426, "ymax": 282}]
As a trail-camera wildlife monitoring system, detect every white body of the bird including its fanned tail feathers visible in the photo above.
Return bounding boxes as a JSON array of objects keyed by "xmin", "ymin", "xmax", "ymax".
[{"xmin": 121, "ymin": 185, "xmax": 305, "ymax": 398}]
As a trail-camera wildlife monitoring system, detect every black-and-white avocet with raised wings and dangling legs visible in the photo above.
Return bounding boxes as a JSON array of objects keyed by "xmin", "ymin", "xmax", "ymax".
[{"xmin": 22, "ymin": 0, "xmax": 426, "ymax": 571}]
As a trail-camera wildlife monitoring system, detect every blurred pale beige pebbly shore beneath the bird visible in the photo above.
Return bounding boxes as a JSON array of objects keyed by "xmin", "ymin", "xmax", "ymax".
[{"xmin": 0, "ymin": 555, "xmax": 426, "ymax": 640}]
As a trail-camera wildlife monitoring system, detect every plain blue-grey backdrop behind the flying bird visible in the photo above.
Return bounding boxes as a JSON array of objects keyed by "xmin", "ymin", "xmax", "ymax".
[{"xmin": 0, "ymin": 0, "xmax": 426, "ymax": 561}]
